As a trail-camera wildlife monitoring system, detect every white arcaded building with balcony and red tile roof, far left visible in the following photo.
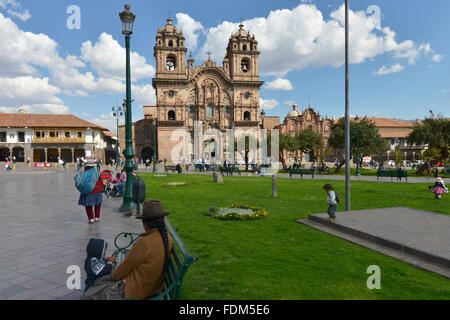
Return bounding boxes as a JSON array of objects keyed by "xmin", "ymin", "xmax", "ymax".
[{"xmin": 0, "ymin": 111, "xmax": 112, "ymax": 163}]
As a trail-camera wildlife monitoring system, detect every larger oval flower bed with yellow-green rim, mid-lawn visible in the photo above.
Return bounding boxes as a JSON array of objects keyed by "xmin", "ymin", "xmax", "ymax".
[{"xmin": 205, "ymin": 205, "xmax": 269, "ymax": 221}]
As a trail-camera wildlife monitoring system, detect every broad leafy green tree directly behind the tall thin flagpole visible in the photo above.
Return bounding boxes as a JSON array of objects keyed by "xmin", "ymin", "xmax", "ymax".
[{"xmin": 328, "ymin": 117, "xmax": 387, "ymax": 172}]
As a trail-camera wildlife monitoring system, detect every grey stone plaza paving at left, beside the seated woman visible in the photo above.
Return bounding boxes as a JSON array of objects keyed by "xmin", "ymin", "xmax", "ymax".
[{"xmin": 0, "ymin": 170, "xmax": 142, "ymax": 300}]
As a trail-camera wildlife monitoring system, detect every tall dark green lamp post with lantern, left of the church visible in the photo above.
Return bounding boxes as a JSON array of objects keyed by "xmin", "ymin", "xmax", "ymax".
[{"xmin": 119, "ymin": 4, "xmax": 136, "ymax": 212}]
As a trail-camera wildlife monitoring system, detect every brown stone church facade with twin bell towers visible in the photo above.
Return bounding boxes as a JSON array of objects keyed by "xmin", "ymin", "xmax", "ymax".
[{"xmin": 146, "ymin": 19, "xmax": 264, "ymax": 162}]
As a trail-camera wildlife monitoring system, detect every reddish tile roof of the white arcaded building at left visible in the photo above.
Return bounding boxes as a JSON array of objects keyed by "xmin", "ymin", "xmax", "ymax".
[{"xmin": 0, "ymin": 113, "xmax": 109, "ymax": 131}]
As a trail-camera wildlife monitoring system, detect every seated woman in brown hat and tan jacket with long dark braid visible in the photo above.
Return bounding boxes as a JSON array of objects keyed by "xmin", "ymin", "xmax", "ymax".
[{"xmin": 81, "ymin": 201, "xmax": 173, "ymax": 300}]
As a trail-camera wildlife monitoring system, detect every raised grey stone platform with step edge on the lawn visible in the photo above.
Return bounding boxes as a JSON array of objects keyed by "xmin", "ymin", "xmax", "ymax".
[{"xmin": 299, "ymin": 207, "xmax": 450, "ymax": 278}]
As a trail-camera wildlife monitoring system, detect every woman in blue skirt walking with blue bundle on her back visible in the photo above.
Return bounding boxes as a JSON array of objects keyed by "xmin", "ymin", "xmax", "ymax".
[{"xmin": 75, "ymin": 160, "xmax": 103, "ymax": 224}]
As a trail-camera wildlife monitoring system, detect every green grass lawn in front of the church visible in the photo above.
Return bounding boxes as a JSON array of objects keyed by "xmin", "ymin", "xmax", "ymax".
[{"xmin": 141, "ymin": 174, "xmax": 450, "ymax": 300}]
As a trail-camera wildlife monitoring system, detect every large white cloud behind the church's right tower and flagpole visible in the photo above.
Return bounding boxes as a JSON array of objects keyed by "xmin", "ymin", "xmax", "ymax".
[{"xmin": 198, "ymin": 4, "xmax": 433, "ymax": 77}]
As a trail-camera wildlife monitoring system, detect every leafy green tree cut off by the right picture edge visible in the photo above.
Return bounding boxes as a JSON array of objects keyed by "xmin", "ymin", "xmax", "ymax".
[{"xmin": 408, "ymin": 110, "xmax": 450, "ymax": 160}]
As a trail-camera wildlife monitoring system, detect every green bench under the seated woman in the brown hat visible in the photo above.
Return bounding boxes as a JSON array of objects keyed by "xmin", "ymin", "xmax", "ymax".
[{"xmin": 113, "ymin": 218, "xmax": 198, "ymax": 300}]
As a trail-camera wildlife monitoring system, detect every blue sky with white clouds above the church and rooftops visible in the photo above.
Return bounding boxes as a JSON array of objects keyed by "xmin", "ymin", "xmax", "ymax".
[{"xmin": 0, "ymin": 0, "xmax": 450, "ymax": 129}]
